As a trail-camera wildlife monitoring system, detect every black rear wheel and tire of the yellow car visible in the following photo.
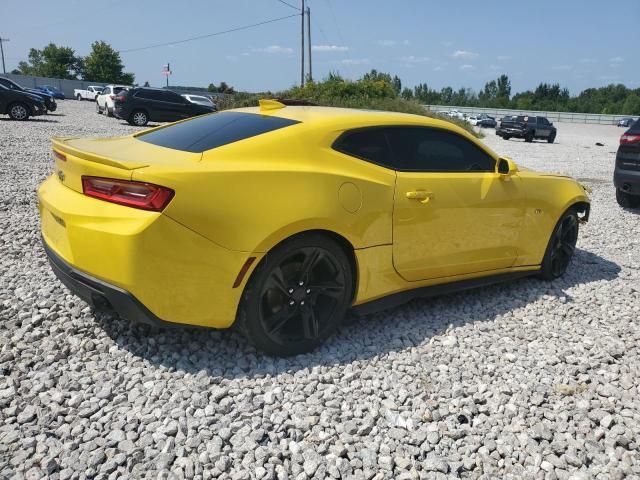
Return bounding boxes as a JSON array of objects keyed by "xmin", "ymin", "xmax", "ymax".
[{"xmin": 236, "ymin": 234, "xmax": 353, "ymax": 357}]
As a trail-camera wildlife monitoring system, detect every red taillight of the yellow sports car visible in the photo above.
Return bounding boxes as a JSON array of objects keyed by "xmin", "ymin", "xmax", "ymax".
[{"xmin": 82, "ymin": 175, "xmax": 174, "ymax": 212}]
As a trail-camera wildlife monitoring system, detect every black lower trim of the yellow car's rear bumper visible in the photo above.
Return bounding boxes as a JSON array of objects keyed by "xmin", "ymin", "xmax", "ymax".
[{"xmin": 42, "ymin": 239, "xmax": 175, "ymax": 326}]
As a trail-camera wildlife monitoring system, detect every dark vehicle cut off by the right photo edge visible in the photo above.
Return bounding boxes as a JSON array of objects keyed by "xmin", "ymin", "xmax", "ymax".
[{"xmin": 613, "ymin": 121, "xmax": 640, "ymax": 208}]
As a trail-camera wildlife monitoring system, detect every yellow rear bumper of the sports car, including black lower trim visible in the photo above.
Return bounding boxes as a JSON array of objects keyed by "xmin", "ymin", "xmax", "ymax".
[{"xmin": 38, "ymin": 175, "xmax": 255, "ymax": 328}]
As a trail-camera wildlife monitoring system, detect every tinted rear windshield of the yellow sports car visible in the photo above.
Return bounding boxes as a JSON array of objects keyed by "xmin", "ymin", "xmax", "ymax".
[{"xmin": 137, "ymin": 112, "xmax": 300, "ymax": 153}]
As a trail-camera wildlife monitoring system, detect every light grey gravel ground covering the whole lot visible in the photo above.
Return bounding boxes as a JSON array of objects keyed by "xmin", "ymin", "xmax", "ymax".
[{"xmin": 0, "ymin": 101, "xmax": 640, "ymax": 479}]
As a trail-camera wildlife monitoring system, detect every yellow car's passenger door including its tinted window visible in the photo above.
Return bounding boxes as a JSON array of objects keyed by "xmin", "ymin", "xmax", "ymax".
[{"xmin": 387, "ymin": 127, "xmax": 525, "ymax": 281}]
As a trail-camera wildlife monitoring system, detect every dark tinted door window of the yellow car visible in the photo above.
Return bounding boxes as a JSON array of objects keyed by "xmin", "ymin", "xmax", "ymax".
[{"xmin": 387, "ymin": 127, "xmax": 495, "ymax": 172}]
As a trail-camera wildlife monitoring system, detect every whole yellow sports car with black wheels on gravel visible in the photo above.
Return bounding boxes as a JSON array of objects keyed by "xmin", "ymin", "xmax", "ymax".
[{"xmin": 38, "ymin": 100, "xmax": 589, "ymax": 355}]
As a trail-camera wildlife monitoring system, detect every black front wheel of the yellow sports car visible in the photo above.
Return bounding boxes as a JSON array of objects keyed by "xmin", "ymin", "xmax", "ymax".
[{"xmin": 540, "ymin": 209, "xmax": 578, "ymax": 280}]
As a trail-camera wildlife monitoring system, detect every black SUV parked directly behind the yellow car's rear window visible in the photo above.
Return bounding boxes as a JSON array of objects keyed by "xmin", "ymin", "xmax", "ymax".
[{"xmin": 114, "ymin": 88, "xmax": 215, "ymax": 127}]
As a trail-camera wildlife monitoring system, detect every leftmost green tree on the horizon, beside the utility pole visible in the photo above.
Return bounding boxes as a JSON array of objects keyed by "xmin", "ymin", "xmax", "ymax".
[{"xmin": 18, "ymin": 43, "xmax": 82, "ymax": 80}]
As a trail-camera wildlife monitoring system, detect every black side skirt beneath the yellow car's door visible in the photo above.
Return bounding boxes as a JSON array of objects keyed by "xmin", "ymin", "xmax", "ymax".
[{"xmin": 351, "ymin": 270, "xmax": 539, "ymax": 316}]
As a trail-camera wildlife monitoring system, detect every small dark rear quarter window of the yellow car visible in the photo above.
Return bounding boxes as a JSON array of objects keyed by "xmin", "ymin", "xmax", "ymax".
[{"xmin": 333, "ymin": 128, "xmax": 395, "ymax": 168}]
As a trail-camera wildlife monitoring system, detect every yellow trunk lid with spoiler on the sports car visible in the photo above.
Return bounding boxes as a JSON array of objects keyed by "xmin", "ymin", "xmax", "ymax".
[{"xmin": 52, "ymin": 135, "xmax": 202, "ymax": 192}]
